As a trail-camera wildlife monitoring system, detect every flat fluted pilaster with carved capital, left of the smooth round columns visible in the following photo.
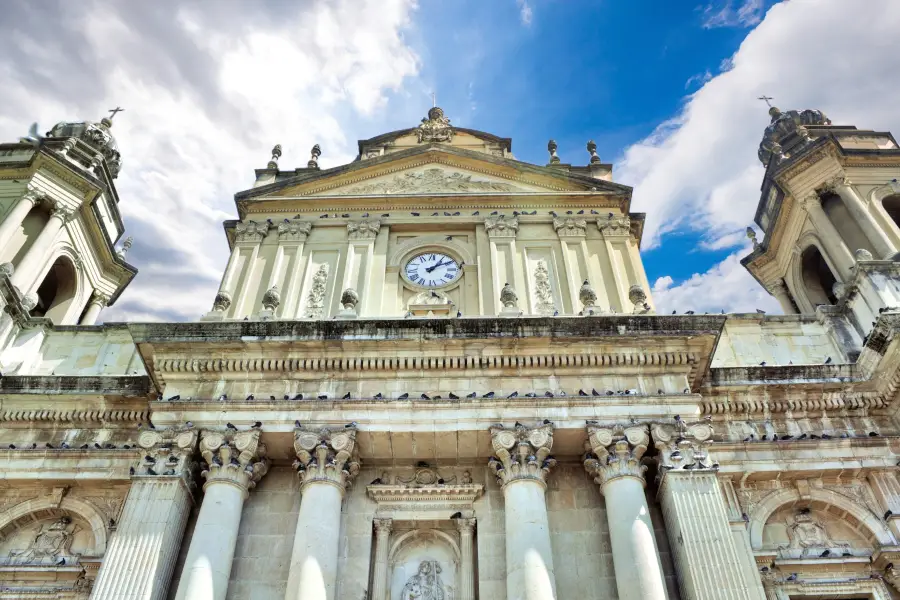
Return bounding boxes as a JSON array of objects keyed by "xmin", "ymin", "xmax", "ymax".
[{"xmin": 91, "ymin": 430, "xmax": 197, "ymax": 600}]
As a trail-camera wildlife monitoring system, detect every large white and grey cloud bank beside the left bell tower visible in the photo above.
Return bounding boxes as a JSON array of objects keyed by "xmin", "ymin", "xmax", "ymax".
[{"xmin": 0, "ymin": 0, "xmax": 420, "ymax": 320}]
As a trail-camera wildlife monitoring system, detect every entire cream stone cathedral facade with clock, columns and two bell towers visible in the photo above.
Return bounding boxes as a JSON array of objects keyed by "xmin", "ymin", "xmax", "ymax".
[{"xmin": 0, "ymin": 107, "xmax": 900, "ymax": 600}]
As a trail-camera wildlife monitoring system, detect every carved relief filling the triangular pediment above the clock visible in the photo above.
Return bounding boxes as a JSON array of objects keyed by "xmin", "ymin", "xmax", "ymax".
[{"xmin": 341, "ymin": 167, "xmax": 521, "ymax": 195}]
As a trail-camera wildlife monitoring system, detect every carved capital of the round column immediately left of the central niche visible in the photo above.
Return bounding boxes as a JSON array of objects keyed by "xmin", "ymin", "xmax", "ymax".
[{"xmin": 294, "ymin": 427, "xmax": 359, "ymax": 491}]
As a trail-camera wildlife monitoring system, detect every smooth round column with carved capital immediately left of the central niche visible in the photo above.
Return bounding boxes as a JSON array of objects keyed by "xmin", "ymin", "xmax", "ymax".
[{"xmin": 284, "ymin": 427, "xmax": 359, "ymax": 600}]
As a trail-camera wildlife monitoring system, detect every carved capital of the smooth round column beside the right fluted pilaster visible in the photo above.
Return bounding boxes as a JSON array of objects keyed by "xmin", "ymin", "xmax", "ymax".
[{"xmin": 584, "ymin": 425, "xmax": 650, "ymax": 491}]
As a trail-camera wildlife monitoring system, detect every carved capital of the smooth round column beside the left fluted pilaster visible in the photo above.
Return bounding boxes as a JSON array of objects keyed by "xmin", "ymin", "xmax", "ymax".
[{"xmin": 200, "ymin": 429, "xmax": 269, "ymax": 495}]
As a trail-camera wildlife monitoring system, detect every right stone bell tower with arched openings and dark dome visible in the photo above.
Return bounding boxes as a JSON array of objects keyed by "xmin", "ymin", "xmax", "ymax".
[{"xmin": 742, "ymin": 106, "xmax": 900, "ymax": 338}]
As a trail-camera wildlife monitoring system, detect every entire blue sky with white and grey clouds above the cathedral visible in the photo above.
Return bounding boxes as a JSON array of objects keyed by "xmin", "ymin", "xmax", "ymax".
[{"xmin": 0, "ymin": 0, "xmax": 900, "ymax": 321}]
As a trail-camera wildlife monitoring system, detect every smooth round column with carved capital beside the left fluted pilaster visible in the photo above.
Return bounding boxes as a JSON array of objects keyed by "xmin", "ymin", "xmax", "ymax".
[{"xmin": 175, "ymin": 429, "xmax": 269, "ymax": 600}]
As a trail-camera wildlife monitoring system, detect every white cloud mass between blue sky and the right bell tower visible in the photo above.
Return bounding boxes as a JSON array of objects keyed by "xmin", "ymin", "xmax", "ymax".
[{"xmin": 617, "ymin": 0, "xmax": 900, "ymax": 310}]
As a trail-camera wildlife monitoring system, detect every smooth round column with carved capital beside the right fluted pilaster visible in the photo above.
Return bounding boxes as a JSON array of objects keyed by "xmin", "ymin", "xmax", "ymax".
[{"xmin": 584, "ymin": 425, "xmax": 666, "ymax": 600}]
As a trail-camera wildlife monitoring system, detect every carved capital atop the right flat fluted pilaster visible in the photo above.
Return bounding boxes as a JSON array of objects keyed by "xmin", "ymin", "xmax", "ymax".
[{"xmin": 651, "ymin": 419, "xmax": 719, "ymax": 477}]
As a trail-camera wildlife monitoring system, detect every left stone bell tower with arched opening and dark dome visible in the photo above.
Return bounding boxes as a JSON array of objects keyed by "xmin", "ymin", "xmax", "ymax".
[{"xmin": 0, "ymin": 111, "xmax": 137, "ymax": 342}]
